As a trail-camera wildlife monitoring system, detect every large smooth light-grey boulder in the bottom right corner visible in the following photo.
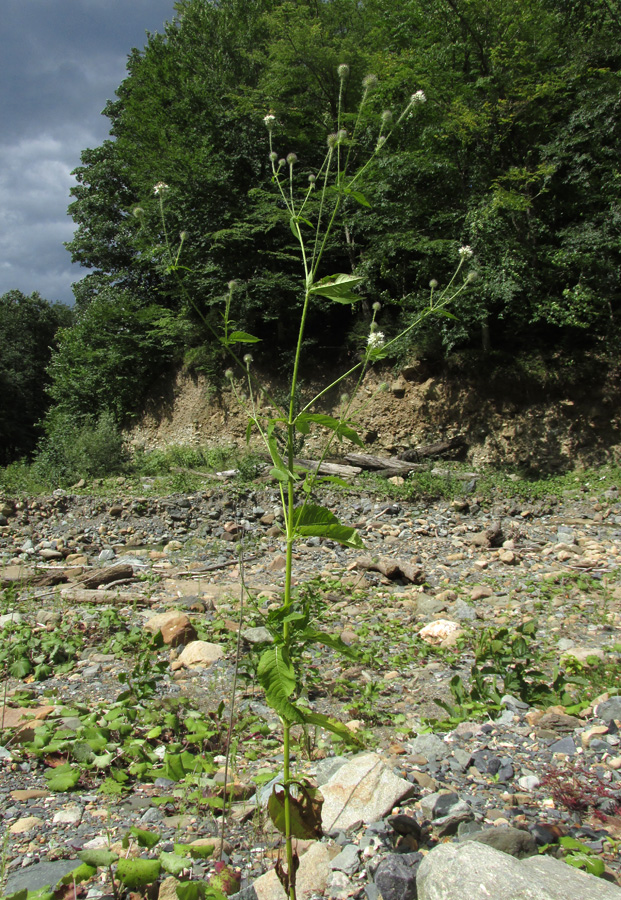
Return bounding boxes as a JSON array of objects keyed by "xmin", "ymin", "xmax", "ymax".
[{"xmin": 417, "ymin": 841, "xmax": 621, "ymax": 900}]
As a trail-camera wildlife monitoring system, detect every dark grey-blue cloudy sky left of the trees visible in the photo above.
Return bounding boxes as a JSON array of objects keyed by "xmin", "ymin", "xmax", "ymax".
[{"xmin": 0, "ymin": 0, "xmax": 174, "ymax": 303}]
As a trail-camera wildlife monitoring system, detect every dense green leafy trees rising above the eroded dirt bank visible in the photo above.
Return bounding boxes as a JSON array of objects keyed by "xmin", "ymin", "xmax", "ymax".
[{"xmin": 44, "ymin": 0, "xmax": 621, "ymax": 421}]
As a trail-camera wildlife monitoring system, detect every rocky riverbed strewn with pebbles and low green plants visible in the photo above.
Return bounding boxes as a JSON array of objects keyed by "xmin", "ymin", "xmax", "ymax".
[{"xmin": 0, "ymin": 483, "xmax": 621, "ymax": 900}]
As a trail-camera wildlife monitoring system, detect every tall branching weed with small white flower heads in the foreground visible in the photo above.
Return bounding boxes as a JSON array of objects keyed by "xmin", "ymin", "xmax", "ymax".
[{"xmin": 153, "ymin": 64, "xmax": 474, "ymax": 900}]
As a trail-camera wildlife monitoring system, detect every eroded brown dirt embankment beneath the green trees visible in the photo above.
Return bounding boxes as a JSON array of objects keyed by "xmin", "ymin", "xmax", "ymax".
[{"xmin": 129, "ymin": 362, "xmax": 621, "ymax": 473}]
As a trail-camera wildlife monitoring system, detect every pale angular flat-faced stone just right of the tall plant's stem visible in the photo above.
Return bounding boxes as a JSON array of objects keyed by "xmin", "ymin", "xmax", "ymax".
[{"xmin": 321, "ymin": 753, "xmax": 416, "ymax": 832}]
